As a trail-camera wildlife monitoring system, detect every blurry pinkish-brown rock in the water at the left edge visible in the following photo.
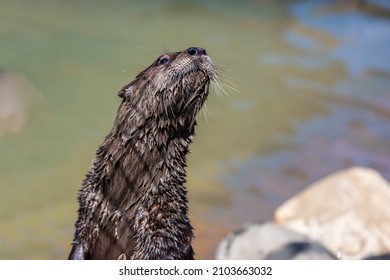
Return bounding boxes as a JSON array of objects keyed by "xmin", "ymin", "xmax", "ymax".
[{"xmin": 0, "ymin": 70, "xmax": 43, "ymax": 137}]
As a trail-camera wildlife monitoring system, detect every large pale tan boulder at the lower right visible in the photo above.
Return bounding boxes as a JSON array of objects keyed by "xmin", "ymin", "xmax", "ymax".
[{"xmin": 275, "ymin": 167, "xmax": 390, "ymax": 259}]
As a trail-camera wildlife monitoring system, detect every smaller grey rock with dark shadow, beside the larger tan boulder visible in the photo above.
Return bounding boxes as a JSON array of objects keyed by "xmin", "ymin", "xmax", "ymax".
[{"xmin": 215, "ymin": 222, "xmax": 335, "ymax": 260}]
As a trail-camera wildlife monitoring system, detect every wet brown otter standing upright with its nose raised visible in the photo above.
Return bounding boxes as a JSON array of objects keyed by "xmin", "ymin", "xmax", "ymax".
[{"xmin": 69, "ymin": 47, "xmax": 217, "ymax": 259}]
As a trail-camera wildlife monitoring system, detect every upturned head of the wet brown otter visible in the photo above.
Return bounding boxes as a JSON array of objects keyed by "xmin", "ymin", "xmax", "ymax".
[{"xmin": 118, "ymin": 47, "xmax": 217, "ymax": 126}]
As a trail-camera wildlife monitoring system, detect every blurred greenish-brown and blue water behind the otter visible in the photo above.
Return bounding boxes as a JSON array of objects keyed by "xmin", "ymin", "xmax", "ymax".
[{"xmin": 0, "ymin": 0, "xmax": 390, "ymax": 259}]
